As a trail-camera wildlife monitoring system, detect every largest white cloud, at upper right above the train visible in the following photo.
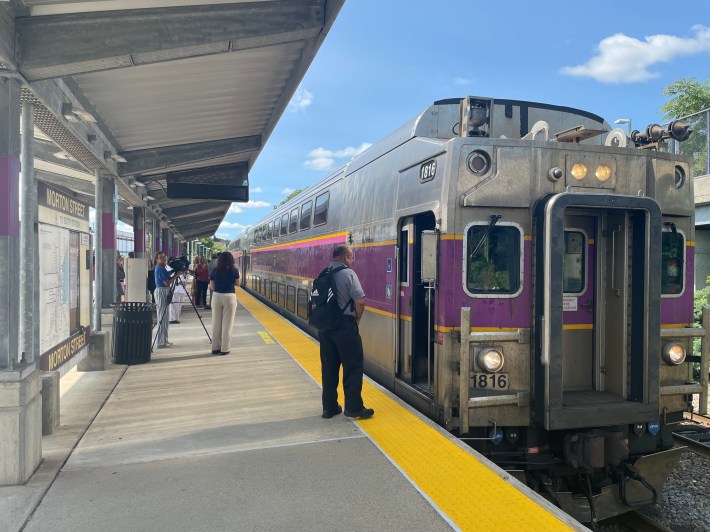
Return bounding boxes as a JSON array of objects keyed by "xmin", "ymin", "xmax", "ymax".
[{"xmin": 561, "ymin": 25, "xmax": 710, "ymax": 83}]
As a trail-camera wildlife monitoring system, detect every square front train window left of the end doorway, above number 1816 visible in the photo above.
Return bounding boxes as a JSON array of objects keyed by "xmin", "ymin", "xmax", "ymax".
[{"xmin": 466, "ymin": 223, "xmax": 521, "ymax": 295}]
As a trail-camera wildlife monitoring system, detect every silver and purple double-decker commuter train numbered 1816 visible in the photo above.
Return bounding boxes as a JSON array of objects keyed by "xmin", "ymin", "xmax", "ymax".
[{"xmin": 230, "ymin": 97, "xmax": 700, "ymax": 522}]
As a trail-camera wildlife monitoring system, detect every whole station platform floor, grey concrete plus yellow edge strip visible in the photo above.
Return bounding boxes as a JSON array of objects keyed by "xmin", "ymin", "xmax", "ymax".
[{"xmin": 0, "ymin": 290, "xmax": 586, "ymax": 532}]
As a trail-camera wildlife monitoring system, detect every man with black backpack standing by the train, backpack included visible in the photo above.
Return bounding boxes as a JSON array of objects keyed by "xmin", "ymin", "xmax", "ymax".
[{"xmin": 309, "ymin": 245, "xmax": 375, "ymax": 419}]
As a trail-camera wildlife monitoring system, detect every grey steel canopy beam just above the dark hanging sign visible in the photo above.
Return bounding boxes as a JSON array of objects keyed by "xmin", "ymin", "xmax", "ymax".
[{"xmin": 118, "ymin": 135, "xmax": 261, "ymax": 176}]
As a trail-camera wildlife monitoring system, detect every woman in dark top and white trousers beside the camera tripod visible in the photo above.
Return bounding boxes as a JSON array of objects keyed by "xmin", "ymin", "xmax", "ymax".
[{"xmin": 210, "ymin": 251, "xmax": 239, "ymax": 355}]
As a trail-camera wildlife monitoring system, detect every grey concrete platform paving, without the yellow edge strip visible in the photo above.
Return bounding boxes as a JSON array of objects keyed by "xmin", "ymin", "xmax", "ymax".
[{"xmin": 0, "ymin": 306, "xmax": 451, "ymax": 532}]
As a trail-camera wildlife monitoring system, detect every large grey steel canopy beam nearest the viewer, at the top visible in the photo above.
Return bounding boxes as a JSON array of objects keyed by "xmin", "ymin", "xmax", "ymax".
[{"xmin": 15, "ymin": 0, "xmax": 325, "ymax": 80}]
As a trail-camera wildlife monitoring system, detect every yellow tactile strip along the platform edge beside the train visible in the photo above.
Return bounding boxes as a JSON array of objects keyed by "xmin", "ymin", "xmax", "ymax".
[{"xmin": 239, "ymin": 289, "xmax": 573, "ymax": 532}]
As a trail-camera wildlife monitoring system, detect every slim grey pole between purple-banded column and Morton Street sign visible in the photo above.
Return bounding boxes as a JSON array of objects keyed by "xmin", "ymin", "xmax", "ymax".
[{"xmin": 19, "ymin": 102, "xmax": 40, "ymax": 364}]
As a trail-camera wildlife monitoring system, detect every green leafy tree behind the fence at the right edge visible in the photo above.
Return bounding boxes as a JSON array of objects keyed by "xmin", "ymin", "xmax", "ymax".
[{"xmin": 661, "ymin": 77, "xmax": 710, "ymax": 176}]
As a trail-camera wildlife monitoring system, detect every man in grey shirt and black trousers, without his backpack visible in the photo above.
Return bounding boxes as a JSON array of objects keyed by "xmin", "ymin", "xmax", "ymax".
[{"xmin": 318, "ymin": 245, "xmax": 375, "ymax": 419}]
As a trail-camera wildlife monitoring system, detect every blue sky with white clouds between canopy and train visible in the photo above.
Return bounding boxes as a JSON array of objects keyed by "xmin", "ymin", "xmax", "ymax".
[{"xmin": 217, "ymin": 0, "xmax": 710, "ymax": 238}]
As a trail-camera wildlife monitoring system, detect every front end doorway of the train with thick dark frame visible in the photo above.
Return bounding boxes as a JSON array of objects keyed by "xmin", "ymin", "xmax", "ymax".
[{"xmin": 534, "ymin": 193, "xmax": 662, "ymax": 430}]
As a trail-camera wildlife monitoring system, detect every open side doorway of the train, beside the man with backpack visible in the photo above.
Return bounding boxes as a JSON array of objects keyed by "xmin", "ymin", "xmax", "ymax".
[{"xmin": 397, "ymin": 212, "xmax": 436, "ymax": 394}]
